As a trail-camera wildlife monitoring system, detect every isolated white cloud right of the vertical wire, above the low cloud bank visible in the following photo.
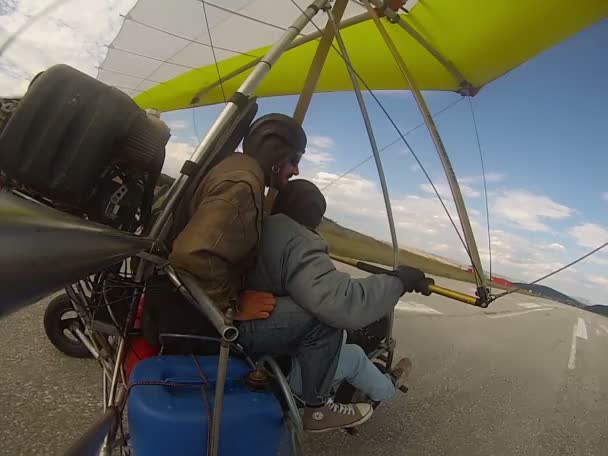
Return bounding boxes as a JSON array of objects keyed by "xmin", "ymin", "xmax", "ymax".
[{"xmin": 492, "ymin": 190, "xmax": 573, "ymax": 231}]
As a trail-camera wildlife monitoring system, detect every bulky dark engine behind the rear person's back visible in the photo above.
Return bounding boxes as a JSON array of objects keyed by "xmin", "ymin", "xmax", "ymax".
[{"xmin": 0, "ymin": 65, "xmax": 170, "ymax": 232}]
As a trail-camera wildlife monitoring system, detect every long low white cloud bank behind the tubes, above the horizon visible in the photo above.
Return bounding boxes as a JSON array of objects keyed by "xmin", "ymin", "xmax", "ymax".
[{"xmin": 317, "ymin": 174, "xmax": 565, "ymax": 281}]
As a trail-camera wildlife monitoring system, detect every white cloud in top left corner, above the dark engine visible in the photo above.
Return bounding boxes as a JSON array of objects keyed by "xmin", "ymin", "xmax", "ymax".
[{"xmin": 0, "ymin": 0, "xmax": 135, "ymax": 95}]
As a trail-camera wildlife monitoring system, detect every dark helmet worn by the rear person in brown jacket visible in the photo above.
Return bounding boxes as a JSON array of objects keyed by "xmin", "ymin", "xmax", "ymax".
[{"xmin": 243, "ymin": 113, "xmax": 306, "ymax": 155}]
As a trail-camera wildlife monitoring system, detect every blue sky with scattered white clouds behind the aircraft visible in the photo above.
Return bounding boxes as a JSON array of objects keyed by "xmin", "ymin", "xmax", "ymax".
[{"xmin": 0, "ymin": 0, "xmax": 608, "ymax": 304}]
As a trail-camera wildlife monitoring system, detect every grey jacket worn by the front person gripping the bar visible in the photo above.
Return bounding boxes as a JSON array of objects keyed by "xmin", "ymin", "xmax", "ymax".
[{"xmin": 247, "ymin": 214, "xmax": 403, "ymax": 330}]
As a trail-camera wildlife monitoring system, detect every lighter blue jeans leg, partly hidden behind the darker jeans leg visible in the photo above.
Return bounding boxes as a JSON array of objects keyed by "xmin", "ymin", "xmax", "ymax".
[{"xmin": 288, "ymin": 344, "xmax": 395, "ymax": 401}]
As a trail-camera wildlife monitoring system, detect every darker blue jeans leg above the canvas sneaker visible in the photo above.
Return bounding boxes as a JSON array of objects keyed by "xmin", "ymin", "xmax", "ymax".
[{"xmin": 238, "ymin": 297, "xmax": 343, "ymax": 405}]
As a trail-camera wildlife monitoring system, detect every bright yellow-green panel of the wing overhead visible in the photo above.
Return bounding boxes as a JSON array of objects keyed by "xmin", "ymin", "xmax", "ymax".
[{"xmin": 121, "ymin": 0, "xmax": 608, "ymax": 111}]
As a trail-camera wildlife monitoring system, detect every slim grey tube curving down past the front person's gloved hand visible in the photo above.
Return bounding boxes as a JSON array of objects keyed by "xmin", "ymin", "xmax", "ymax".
[{"xmin": 327, "ymin": 10, "xmax": 399, "ymax": 369}]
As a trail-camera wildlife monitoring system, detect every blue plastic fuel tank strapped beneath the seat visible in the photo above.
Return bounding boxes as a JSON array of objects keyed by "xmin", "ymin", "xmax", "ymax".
[{"xmin": 128, "ymin": 356, "xmax": 285, "ymax": 456}]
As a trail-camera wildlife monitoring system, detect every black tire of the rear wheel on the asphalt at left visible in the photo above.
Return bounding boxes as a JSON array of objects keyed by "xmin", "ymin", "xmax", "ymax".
[{"xmin": 44, "ymin": 294, "xmax": 93, "ymax": 358}]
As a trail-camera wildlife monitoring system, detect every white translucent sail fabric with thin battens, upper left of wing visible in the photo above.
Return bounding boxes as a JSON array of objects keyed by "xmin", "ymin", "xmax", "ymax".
[{"xmin": 97, "ymin": 0, "xmax": 365, "ymax": 97}]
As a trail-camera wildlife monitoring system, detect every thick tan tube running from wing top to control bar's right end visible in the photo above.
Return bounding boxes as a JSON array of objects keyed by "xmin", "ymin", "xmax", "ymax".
[{"xmin": 363, "ymin": 0, "xmax": 489, "ymax": 302}]
